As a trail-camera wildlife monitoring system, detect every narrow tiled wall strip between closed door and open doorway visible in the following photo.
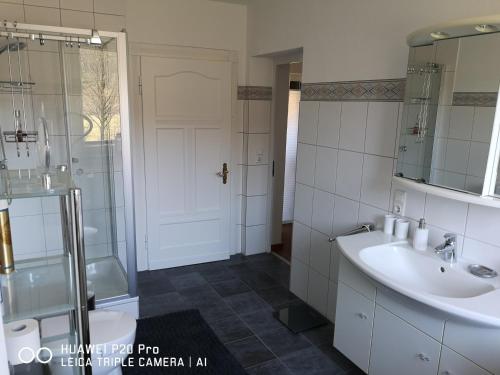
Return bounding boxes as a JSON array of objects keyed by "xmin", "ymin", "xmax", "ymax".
[{"xmin": 238, "ymin": 86, "xmax": 272, "ymax": 255}]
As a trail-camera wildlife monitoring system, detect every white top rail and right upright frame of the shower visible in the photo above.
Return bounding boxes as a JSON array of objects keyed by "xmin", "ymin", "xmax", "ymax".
[{"xmin": 5, "ymin": 22, "xmax": 137, "ymax": 301}]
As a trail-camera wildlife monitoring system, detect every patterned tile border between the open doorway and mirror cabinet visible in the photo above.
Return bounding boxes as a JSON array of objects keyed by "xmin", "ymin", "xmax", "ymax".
[{"xmin": 300, "ymin": 78, "xmax": 406, "ymax": 102}]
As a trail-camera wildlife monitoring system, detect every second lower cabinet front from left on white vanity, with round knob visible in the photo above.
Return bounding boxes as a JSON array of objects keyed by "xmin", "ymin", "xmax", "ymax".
[{"xmin": 370, "ymin": 306, "xmax": 441, "ymax": 375}]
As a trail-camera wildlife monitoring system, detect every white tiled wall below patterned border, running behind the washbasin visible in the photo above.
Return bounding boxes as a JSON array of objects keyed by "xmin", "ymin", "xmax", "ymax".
[{"xmin": 290, "ymin": 80, "xmax": 500, "ymax": 321}]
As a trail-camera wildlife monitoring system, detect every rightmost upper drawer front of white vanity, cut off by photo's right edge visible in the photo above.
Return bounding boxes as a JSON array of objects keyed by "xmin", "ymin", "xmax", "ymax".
[{"xmin": 443, "ymin": 321, "xmax": 500, "ymax": 374}]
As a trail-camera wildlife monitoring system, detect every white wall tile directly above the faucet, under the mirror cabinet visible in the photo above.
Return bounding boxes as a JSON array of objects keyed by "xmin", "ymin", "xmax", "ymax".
[{"xmin": 425, "ymin": 194, "xmax": 468, "ymax": 234}]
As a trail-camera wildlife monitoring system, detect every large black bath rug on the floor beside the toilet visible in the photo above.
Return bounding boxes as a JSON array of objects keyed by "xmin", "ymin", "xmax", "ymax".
[{"xmin": 122, "ymin": 310, "xmax": 246, "ymax": 375}]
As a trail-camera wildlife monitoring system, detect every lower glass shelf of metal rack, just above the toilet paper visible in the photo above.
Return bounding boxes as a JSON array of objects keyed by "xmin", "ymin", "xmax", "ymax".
[{"xmin": 1, "ymin": 255, "xmax": 74, "ymax": 323}]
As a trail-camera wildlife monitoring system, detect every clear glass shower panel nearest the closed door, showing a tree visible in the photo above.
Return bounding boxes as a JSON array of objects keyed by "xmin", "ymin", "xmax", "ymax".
[{"xmin": 62, "ymin": 39, "xmax": 128, "ymax": 300}]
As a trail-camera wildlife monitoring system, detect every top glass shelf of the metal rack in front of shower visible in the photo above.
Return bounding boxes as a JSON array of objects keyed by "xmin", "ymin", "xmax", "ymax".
[{"xmin": 0, "ymin": 169, "xmax": 75, "ymax": 199}]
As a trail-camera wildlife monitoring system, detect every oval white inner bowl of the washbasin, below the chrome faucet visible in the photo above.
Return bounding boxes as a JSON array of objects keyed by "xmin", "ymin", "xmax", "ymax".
[{"xmin": 359, "ymin": 244, "xmax": 495, "ymax": 298}]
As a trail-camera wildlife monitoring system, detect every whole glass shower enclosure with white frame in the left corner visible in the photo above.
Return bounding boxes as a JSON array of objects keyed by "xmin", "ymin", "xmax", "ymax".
[{"xmin": 0, "ymin": 23, "xmax": 136, "ymax": 304}]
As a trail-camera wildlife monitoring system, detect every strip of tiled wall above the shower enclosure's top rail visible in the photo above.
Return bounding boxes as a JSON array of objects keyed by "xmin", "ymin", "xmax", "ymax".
[{"xmin": 0, "ymin": 0, "xmax": 125, "ymax": 31}]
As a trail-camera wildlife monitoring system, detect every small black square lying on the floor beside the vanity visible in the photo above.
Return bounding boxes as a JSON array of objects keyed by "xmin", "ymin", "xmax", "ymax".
[{"xmin": 274, "ymin": 303, "xmax": 328, "ymax": 333}]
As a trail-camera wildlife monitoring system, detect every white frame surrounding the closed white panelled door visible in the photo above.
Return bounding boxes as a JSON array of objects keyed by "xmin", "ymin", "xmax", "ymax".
[{"xmin": 129, "ymin": 42, "xmax": 242, "ymax": 271}]
